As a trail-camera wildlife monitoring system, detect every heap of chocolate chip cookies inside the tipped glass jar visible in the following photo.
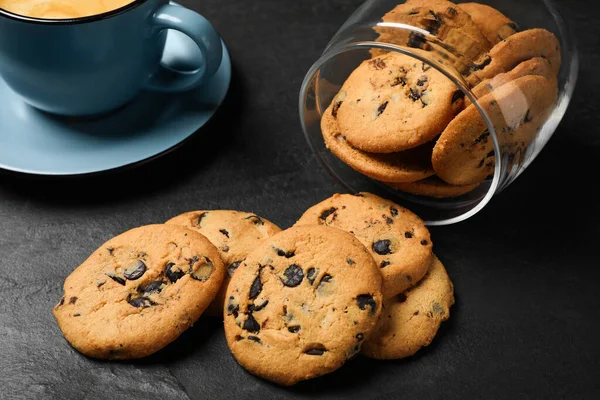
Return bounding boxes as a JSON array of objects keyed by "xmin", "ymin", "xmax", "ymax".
[{"xmin": 321, "ymin": 0, "xmax": 561, "ymax": 198}]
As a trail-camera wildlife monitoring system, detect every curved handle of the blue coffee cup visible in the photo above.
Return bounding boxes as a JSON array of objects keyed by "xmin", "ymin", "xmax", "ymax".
[{"xmin": 146, "ymin": 4, "xmax": 223, "ymax": 92}]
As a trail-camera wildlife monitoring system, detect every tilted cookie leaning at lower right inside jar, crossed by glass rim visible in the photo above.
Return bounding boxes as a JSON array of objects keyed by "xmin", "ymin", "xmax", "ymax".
[{"xmin": 432, "ymin": 75, "xmax": 557, "ymax": 185}]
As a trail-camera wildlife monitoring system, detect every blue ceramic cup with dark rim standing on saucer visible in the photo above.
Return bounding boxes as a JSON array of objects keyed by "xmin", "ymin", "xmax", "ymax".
[{"xmin": 0, "ymin": 0, "xmax": 222, "ymax": 116}]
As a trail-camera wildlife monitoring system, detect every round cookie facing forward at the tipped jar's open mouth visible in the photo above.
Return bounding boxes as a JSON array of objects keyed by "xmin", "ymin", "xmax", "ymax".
[{"xmin": 332, "ymin": 53, "xmax": 462, "ymax": 153}]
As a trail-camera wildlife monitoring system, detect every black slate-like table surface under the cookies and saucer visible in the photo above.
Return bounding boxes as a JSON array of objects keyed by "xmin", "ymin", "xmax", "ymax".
[{"xmin": 0, "ymin": 0, "xmax": 600, "ymax": 399}]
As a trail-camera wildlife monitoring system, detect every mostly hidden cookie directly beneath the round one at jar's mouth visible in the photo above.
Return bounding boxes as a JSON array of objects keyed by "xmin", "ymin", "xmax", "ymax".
[{"xmin": 321, "ymin": 106, "xmax": 434, "ymax": 182}]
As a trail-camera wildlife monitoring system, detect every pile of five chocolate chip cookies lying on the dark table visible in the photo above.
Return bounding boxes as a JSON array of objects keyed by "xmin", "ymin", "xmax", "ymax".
[{"xmin": 54, "ymin": 193, "xmax": 454, "ymax": 386}]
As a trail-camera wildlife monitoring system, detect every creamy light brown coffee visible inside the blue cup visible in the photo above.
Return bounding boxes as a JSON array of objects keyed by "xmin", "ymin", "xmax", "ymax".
[{"xmin": 0, "ymin": 0, "xmax": 135, "ymax": 19}]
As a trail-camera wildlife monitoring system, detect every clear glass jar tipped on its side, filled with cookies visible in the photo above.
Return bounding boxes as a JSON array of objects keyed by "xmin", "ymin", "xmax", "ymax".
[{"xmin": 300, "ymin": 0, "xmax": 578, "ymax": 226}]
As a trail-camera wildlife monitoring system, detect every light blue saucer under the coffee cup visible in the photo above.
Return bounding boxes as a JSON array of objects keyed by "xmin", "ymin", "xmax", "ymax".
[{"xmin": 0, "ymin": 31, "xmax": 231, "ymax": 175}]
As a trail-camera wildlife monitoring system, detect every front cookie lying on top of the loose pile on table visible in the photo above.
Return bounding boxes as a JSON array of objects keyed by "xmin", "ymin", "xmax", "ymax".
[{"xmin": 225, "ymin": 226, "xmax": 382, "ymax": 386}]
